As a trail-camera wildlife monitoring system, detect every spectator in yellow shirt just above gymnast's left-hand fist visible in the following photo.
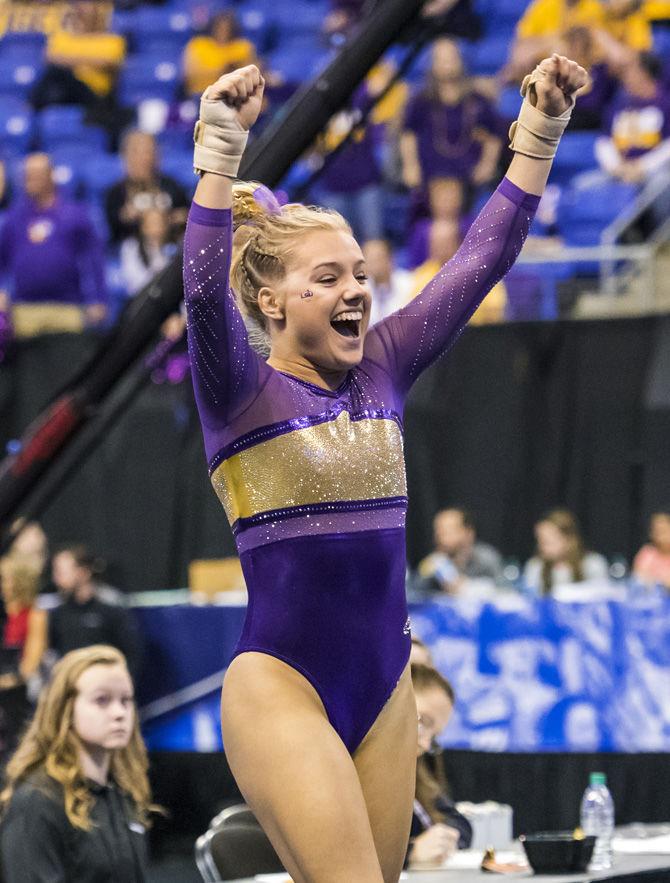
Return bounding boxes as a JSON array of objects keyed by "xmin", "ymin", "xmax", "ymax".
[{"xmin": 182, "ymin": 10, "xmax": 257, "ymax": 95}]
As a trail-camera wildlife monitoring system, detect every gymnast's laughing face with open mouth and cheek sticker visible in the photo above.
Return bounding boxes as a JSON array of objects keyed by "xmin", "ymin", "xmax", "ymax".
[{"xmin": 259, "ymin": 230, "xmax": 371, "ymax": 373}]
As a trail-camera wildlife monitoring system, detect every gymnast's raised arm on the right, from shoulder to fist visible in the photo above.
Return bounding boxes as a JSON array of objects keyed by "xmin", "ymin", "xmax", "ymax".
[{"xmin": 365, "ymin": 55, "xmax": 586, "ymax": 392}]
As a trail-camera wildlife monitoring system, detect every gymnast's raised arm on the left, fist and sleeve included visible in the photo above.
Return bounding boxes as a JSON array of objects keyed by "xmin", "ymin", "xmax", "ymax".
[{"xmin": 184, "ymin": 66, "xmax": 263, "ymax": 448}]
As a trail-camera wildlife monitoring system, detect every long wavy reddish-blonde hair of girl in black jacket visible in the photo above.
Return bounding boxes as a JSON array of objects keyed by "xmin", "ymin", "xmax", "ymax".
[{"xmin": 0, "ymin": 644, "xmax": 153, "ymax": 831}]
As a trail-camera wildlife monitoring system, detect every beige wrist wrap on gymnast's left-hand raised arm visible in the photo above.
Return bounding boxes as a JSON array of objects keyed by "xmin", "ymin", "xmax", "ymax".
[{"xmin": 193, "ymin": 98, "xmax": 249, "ymax": 178}]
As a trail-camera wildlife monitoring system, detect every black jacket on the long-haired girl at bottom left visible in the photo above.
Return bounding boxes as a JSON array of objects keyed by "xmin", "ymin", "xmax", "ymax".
[{"xmin": 0, "ymin": 772, "xmax": 147, "ymax": 883}]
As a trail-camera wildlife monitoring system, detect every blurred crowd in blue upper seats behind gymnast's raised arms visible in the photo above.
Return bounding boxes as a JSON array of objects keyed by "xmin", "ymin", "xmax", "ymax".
[{"xmin": 0, "ymin": 0, "xmax": 670, "ymax": 335}]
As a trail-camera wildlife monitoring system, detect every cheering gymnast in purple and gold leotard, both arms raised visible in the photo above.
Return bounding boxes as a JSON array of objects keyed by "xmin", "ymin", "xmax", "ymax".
[{"xmin": 184, "ymin": 55, "xmax": 586, "ymax": 883}]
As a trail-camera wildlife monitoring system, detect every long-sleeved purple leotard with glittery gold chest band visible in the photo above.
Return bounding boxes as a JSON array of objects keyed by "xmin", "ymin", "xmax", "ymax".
[{"xmin": 184, "ymin": 179, "xmax": 538, "ymax": 753}]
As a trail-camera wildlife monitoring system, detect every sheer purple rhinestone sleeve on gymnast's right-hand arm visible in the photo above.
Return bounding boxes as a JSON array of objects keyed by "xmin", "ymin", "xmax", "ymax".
[{"xmin": 365, "ymin": 178, "xmax": 539, "ymax": 392}]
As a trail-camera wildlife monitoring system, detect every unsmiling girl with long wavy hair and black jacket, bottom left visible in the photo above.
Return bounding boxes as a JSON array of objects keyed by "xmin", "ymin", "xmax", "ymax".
[{"xmin": 0, "ymin": 646, "xmax": 151, "ymax": 883}]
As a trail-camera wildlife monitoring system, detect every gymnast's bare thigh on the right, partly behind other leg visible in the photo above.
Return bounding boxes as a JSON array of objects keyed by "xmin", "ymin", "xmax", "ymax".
[{"xmin": 354, "ymin": 666, "xmax": 417, "ymax": 883}]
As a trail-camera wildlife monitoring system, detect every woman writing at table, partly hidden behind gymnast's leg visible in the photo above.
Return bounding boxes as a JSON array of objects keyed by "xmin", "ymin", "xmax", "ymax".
[{"xmin": 407, "ymin": 663, "xmax": 472, "ymax": 868}]
